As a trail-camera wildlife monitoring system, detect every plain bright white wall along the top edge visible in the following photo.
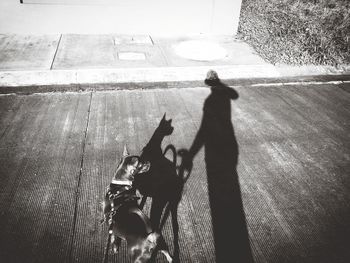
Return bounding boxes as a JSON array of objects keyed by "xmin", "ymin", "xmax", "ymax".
[{"xmin": 0, "ymin": 0, "xmax": 241, "ymax": 36}]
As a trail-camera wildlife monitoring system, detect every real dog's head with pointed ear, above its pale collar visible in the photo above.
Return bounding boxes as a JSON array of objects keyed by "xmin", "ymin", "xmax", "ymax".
[{"xmin": 113, "ymin": 146, "xmax": 151, "ymax": 185}]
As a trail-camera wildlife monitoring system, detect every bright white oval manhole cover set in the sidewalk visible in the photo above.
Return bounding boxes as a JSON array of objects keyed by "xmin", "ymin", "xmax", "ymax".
[{"xmin": 173, "ymin": 40, "xmax": 227, "ymax": 61}]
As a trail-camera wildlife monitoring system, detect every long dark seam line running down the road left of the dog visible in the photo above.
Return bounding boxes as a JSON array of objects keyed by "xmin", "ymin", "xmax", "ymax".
[{"xmin": 69, "ymin": 91, "xmax": 93, "ymax": 262}]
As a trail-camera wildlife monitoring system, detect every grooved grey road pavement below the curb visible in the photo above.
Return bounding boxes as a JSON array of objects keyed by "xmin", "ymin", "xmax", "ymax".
[{"xmin": 0, "ymin": 82, "xmax": 350, "ymax": 263}]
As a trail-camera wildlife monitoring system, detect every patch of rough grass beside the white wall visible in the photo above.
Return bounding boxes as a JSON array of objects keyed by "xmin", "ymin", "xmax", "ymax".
[{"xmin": 238, "ymin": 0, "xmax": 350, "ymax": 66}]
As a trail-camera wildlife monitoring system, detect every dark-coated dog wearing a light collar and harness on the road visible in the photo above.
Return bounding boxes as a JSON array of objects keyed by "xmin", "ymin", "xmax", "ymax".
[{"xmin": 103, "ymin": 147, "xmax": 172, "ymax": 263}]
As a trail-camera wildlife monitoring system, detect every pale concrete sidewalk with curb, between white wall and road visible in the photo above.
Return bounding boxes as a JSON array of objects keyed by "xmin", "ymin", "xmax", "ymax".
[{"xmin": 0, "ymin": 34, "xmax": 349, "ymax": 87}]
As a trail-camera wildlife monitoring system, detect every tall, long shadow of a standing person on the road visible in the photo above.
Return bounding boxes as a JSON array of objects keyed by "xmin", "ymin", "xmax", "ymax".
[{"xmin": 185, "ymin": 71, "xmax": 253, "ymax": 263}]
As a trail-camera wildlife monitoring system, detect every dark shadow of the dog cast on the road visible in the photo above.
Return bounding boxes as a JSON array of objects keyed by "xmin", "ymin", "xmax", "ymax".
[{"xmin": 133, "ymin": 114, "xmax": 185, "ymax": 262}]
